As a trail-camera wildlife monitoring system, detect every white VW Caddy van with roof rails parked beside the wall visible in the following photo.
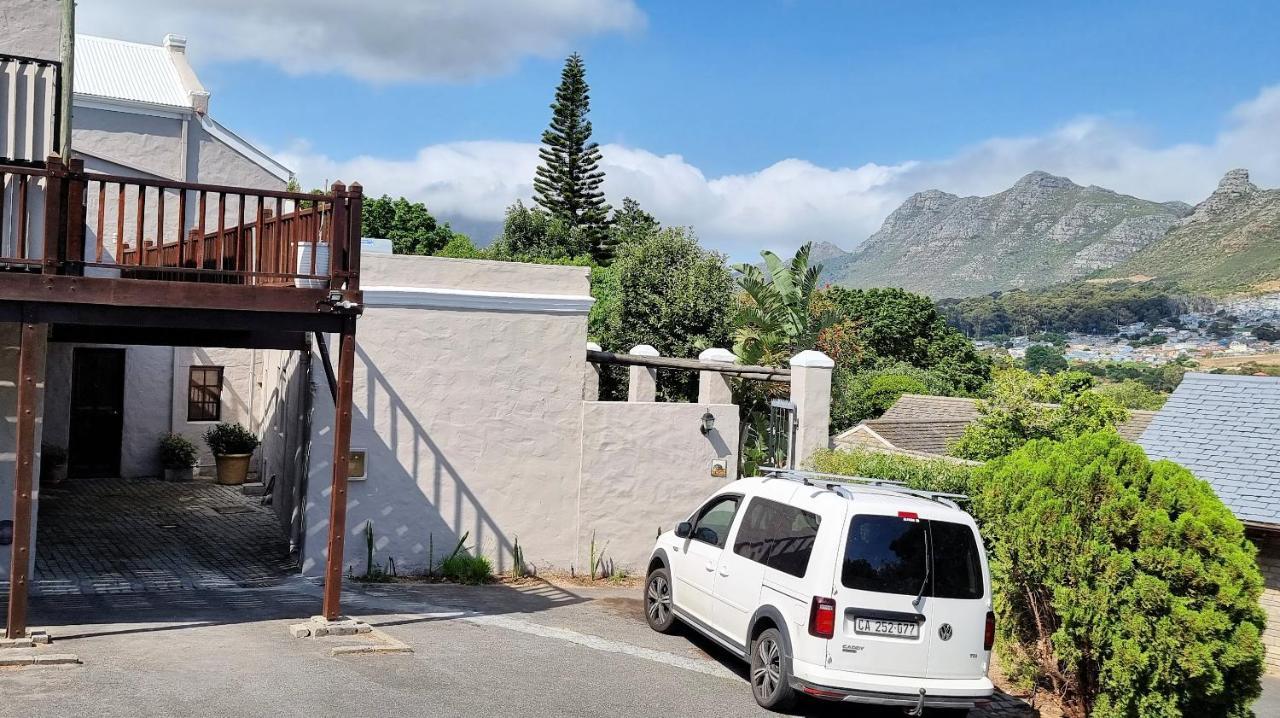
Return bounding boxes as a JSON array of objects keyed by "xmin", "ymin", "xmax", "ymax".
[{"xmin": 644, "ymin": 471, "xmax": 996, "ymax": 715}]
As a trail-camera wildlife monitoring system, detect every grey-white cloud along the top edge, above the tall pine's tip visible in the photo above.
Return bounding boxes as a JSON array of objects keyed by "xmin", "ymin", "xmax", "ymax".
[{"xmin": 77, "ymin": 0, "xmax": 645, "ymax": 82}]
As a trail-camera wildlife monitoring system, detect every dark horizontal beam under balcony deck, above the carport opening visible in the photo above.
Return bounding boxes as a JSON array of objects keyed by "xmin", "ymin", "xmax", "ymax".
[{"xmin": 49, "ymin": 324, "xmax": 307, "ymax": 351}]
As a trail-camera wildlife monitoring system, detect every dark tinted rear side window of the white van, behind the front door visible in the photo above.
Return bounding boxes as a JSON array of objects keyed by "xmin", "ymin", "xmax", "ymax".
[{"xmin": 733, "ymin": 497, "xmax": 822, "ymax": 578}]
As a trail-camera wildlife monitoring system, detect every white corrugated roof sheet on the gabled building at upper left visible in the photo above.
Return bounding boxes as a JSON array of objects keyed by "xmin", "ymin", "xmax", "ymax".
[{"xmin": 76, "ymin": 35, "xmax": 191, "ymax": 108}]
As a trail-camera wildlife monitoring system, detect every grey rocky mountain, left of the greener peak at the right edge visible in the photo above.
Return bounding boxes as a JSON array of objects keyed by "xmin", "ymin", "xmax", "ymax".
[{"xmin": 823, "ymin": 172, "xmax": 1192, "ymax": 297}]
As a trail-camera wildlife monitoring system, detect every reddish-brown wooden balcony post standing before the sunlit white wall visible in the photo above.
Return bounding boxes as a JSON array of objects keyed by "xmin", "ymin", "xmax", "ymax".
[{"xmin": 321, "ymin": 316, "xmax": 356, "ymax": 621}]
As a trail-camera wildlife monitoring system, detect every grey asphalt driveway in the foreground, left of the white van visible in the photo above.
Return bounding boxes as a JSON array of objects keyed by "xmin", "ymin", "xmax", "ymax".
[{"xmin": 0, "ymin": 581, "xmax": 1265, "ymax": 718}]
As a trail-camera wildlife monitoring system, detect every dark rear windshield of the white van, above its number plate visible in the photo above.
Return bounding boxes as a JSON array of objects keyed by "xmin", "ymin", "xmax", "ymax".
[{"xmin": 841, "ymin": 516, "xmax": 986, "ymax": 599}]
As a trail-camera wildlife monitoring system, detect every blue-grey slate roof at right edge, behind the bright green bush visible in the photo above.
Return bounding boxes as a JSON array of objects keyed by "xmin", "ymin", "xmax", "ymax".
[{"xmin": 1138, "ymin": 374, "xmax": 1280, "ymax": 525}]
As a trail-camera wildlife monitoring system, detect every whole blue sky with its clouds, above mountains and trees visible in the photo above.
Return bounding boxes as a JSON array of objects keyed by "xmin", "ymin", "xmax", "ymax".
[{"xmin": 81, "ymin": 0, "xmax": 1280, "ymax": 257}]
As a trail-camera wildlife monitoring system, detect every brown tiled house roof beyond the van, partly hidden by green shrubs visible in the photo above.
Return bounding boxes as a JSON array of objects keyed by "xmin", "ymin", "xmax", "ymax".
[{"xmin": 832, "ymin": 394, "xmax": 1156, "ymax": 458}]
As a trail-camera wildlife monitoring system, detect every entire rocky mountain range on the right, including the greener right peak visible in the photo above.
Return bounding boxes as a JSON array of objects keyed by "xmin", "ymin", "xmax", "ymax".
[{"xmin": 813, "ymin": 170, "xmax": 1280, "ymax": 297}]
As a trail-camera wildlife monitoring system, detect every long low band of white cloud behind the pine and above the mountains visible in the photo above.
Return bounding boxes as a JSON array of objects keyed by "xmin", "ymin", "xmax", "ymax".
[{"xmin": 278, "ymin": 86, "xmax": 1280, "ymax": 260}]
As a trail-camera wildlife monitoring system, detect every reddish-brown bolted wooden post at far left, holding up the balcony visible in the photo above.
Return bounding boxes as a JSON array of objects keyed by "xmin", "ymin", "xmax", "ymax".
[{"xmin": 5, "ymin": 321, "xmax": 47, "ymax": 639}]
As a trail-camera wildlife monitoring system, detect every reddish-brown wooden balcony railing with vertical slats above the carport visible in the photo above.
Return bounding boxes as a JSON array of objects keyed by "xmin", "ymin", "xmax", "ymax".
[{"xmin": 0, "ymin": 157, "xmax": 362, "ymax": 289}]
